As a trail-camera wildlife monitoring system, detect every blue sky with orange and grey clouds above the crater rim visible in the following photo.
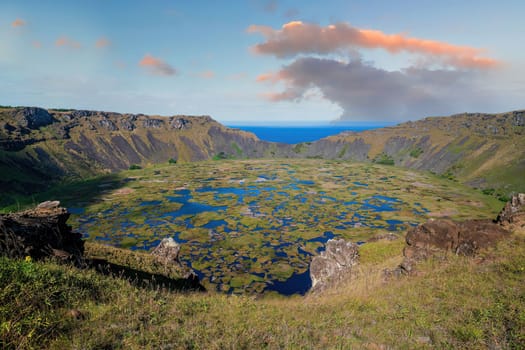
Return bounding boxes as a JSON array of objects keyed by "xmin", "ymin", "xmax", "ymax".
[{"xmin": 0, "ymin": 0, "xmax": 525, "ymax": 125}]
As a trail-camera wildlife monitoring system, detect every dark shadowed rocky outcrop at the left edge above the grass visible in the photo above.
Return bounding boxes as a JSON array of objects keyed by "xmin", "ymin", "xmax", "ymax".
[{"xmin": 0, "ymin": 201, "xmax": 84, "ymax": 264}]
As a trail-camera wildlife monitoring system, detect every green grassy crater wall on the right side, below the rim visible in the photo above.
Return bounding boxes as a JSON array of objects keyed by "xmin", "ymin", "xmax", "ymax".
[{"xmin": 328, "ymin": 112, "xmax": 525, "ymax": 194}]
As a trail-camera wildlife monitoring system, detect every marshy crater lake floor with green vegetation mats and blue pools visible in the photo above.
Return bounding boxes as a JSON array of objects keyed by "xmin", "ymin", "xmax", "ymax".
[{"xmin": 69, "ymin": 159, "xmax": 501, "ymax": 295}]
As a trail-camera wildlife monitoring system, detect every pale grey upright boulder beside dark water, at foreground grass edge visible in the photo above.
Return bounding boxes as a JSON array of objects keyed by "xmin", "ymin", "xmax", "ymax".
[{"xmin": 310, "ymin": 239, "xmax": 359, "ymax": 293}]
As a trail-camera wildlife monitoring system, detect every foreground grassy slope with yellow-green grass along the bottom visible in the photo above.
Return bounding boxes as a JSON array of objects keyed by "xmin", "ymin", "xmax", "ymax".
[{"xmin": 0, "ymin": 228, "xmax": 525, "ymax": 349}]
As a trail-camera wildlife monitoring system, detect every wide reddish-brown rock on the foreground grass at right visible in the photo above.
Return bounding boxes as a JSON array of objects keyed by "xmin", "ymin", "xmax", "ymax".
[{"xmin": 400, "ymin": 219, "xmax": 509, "ymax": 273}]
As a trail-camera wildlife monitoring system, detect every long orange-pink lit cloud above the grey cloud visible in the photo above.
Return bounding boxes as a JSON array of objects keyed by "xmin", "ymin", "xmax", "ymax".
[{"xmin": 247, "ymin": 21, "xmax": 499, "ymax": 69}]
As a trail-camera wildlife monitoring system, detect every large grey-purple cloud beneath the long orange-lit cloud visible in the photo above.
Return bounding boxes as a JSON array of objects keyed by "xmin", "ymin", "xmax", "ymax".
[{"xmin": 258, "ymin": 57, "xmax": 491, "ymax": 120}]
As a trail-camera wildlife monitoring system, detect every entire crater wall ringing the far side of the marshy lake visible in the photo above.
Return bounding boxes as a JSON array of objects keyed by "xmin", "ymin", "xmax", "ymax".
[{"xmin": 0, "ymin": 107, "xmax": 525, "ymax": 206}]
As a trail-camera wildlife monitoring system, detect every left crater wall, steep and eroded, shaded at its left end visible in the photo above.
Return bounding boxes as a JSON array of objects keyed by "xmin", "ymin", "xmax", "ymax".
[{"xmin": 0, "ymin": 107, "xmax": 291, "ymax": 202}]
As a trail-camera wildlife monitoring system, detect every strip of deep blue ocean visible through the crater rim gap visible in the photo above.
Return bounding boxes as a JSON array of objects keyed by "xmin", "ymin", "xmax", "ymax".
[{"xmin": 229, "ymin": 125, "xmax": 384, "ymax": 144}]
